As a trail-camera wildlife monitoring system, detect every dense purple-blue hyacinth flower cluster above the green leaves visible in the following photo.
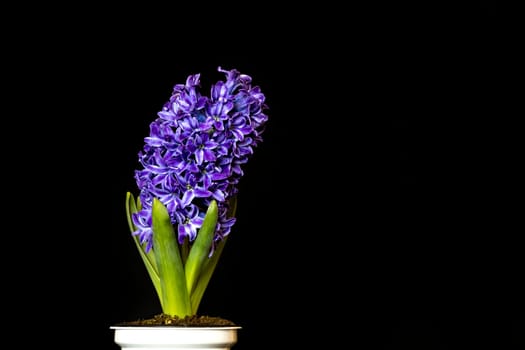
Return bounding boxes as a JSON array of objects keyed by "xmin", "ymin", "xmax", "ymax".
[{"xmin": 132, "ymin": 67, "xmax": 268, "ymax": 254}]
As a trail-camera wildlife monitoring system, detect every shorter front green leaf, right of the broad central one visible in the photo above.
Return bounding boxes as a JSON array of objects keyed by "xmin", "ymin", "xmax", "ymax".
[{"xmin": 185, "ymin": 200, "xmax": 219, "ymax": 295}]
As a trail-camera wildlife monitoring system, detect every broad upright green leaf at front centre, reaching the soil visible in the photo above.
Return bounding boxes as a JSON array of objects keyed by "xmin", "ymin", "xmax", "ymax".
[{"xmin": 152, "ymin": 198, "xmax": 191, "ymax": 317}]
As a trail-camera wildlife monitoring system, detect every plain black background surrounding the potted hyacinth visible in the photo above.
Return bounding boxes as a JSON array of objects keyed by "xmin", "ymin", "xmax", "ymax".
[{"xmin": 3, "ymin": 2, "xmax": 524, "ymax": 350}]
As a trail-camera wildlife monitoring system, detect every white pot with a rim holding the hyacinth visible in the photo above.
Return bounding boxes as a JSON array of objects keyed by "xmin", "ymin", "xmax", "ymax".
[{"xmin": 111, "ymin": 326, "xmax": 241, "ymax": 350}]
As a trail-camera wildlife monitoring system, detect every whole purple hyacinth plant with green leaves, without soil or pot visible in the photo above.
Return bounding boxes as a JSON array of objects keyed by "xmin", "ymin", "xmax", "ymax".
[{"xmin": 126, "ymin": 67, "xmax": 268, "ymax": 317}]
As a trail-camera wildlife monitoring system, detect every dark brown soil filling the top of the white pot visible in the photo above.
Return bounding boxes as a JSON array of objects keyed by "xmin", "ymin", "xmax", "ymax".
[{"xmin": 116, "ymin": 314, "xmax": 237, "ymax": 327}]
